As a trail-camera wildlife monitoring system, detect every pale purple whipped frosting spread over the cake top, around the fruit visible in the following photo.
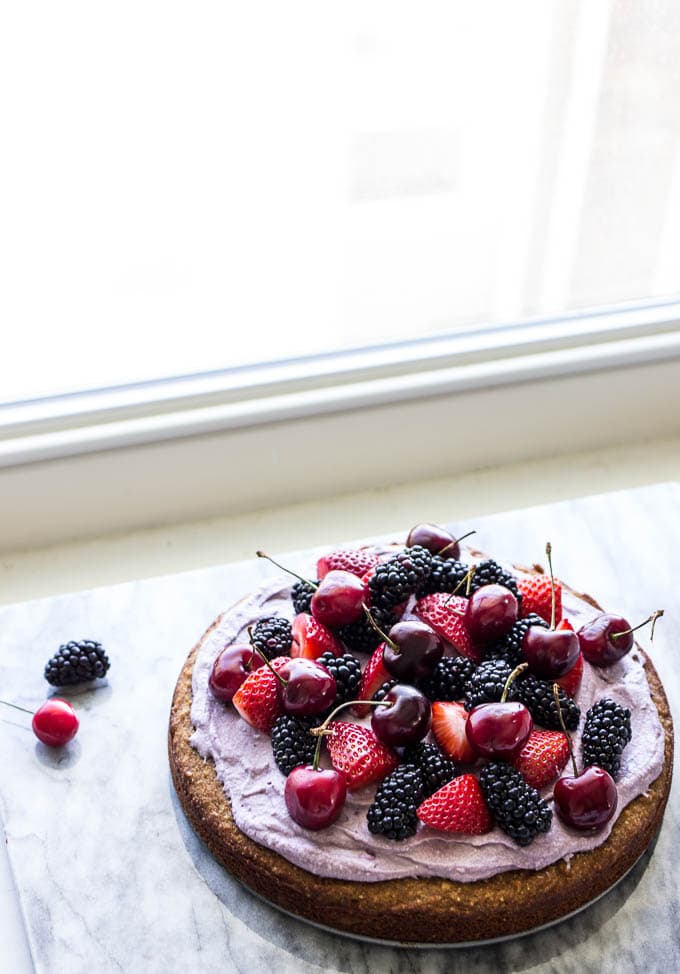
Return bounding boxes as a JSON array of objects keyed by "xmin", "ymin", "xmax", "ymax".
[{"xmin": 191, "ymin": 556, "xmax": 664, "ymax": 882}]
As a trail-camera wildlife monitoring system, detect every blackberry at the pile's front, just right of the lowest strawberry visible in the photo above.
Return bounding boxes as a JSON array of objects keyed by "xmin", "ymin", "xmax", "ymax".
[{"xmin": 479, "ymin": 761, "xmax": 552, "ymax": 845}]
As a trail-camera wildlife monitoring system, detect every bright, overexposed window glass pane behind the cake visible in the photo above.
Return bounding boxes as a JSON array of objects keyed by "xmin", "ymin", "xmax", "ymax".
[{"xmin": 0, "ymin": 0, "xmax": 680, "ymax": 402}]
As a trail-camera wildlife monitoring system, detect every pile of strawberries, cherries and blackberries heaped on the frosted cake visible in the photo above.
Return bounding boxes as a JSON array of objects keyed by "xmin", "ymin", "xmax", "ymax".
[{"xmin": 209, "ymin": 524, "xmax": 660, "ymax": 845}]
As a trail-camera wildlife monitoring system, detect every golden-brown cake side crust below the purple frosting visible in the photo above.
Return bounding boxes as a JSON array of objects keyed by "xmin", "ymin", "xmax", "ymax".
[{"xmin": 168, "ymin": 596, "xmax": 673, "ymax": 944}]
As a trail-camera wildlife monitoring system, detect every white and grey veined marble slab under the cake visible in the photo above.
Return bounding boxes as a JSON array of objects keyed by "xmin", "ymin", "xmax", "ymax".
[{"xmin": 0, "ymin": 484, "xmax": 680, "ymax": 974}]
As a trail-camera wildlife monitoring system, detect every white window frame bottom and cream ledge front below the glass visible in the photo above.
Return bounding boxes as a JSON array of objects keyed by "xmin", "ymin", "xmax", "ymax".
[{"xmin": 0, "ymin": 304, "xmax": 680, "ymax": 550}]
